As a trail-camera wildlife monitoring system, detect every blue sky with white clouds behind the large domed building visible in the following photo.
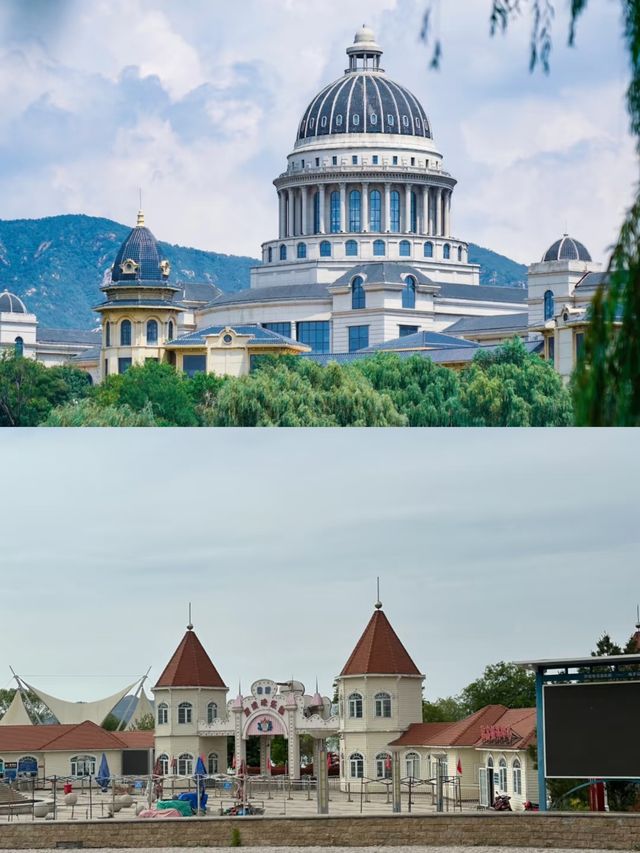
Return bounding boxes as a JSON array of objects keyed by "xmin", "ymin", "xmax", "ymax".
[{"xmin": 0, "ymin": 0, "xmax": 637, "ymax": 263}]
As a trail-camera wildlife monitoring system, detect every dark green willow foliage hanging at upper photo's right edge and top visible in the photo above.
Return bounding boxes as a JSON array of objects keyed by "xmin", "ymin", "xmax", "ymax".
[{"xmin": 420, "ymin": 0, "xmax": 640, "ymax": 426}]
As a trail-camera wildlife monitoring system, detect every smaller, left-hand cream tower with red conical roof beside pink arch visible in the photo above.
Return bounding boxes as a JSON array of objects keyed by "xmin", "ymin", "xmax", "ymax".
[{"xmin": 153, "ymin": 622, "xmax": 228, "ymax": 776}]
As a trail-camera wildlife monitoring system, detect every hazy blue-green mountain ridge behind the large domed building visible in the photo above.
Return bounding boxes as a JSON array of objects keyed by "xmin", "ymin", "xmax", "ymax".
[{"xmin": 0, "ymin": 213, "xmax": 526, "ymax": 329}]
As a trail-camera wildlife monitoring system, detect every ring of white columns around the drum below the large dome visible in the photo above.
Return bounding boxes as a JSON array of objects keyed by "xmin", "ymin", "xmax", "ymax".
[{"xmin": 278, "ymin": 181, "xmax": 453, "ymax": 240}]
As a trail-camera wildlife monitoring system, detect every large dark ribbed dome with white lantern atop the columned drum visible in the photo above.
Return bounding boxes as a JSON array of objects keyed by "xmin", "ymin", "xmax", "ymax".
[{"xmin": 298, "ymin": 27, "xmax": 431, "ymax": 141}]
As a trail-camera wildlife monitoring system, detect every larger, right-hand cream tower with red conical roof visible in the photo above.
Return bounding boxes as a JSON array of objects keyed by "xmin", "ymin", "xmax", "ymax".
[{"xmin": 337, "ymin": 601, "xmax": 424, "ymax": 788}]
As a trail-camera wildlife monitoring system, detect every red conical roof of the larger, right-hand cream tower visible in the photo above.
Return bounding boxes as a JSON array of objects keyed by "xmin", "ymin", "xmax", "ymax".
[{"xmin": 340, "ymin": 609, "xmax": 421, "ymax": 675}]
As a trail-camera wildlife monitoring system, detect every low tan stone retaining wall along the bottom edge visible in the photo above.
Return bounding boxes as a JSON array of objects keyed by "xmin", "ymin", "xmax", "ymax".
[{"xmin": 0, "ymin": 812, "xmax": 640, "ymax": 850}]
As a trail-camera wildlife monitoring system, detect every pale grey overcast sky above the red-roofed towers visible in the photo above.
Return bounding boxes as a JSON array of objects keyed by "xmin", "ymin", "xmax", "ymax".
[{"xmin": 0, "ymin": 430, "xmax": 640, "ymax": 700}]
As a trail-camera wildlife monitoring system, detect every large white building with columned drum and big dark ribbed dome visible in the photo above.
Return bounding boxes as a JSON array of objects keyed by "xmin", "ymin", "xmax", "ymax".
[{"xmin": 199, "ymin": 27, "xmax": 526, "ymax": 357}]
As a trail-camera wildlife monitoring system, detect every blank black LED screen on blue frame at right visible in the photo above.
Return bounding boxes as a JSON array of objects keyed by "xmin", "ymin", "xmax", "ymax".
[{"xmin": 544, "ymin": 681, "xmax": 640, "ymax": 779}]
